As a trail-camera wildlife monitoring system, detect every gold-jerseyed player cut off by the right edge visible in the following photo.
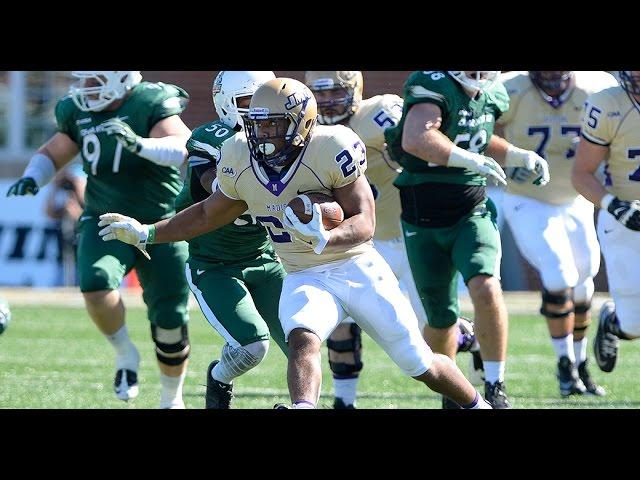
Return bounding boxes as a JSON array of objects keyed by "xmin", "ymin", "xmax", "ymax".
[{"xmin": 571, "ymin": 70, "xmax": 640, "ymax": 372}]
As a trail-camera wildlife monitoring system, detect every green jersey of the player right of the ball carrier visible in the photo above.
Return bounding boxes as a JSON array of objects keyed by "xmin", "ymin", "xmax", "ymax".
[{"xmin": 384, "ymin": 71, "xmax": 509, "ymax": 187}]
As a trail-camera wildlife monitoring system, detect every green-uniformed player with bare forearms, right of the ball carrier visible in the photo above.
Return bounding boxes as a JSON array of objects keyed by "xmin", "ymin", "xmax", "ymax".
[{"xmin": 385, "ymin": 71, "xmax": 549, "ymax": 408}]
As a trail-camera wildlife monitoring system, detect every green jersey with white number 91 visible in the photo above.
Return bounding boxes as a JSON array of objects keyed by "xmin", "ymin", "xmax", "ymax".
[{"xmin": 55, "ymin": 82, "xmax": 189, "ymax": 223}]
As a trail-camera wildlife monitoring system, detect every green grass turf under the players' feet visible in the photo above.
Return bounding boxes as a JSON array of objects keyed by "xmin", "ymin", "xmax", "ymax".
[{"xmin": 0, "ymin": 307, "xmax": 640, "ymax": 408}]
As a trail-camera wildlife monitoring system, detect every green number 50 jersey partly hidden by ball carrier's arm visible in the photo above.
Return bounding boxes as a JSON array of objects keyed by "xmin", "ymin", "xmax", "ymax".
[{"xmin": 176, "ymin": 121, "xmax": 273, "ymax": 268}]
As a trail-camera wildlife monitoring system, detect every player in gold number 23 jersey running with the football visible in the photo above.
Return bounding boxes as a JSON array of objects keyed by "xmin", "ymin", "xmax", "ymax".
[{"xmin": 100, "ymin": 78, "xmax": 489, "ymax": 408}]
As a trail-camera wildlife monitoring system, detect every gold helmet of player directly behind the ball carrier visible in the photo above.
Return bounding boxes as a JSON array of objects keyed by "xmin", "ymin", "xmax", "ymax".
[{"xmin": 304, "ymin": 70, "xmax": 363, "ymax": 125}]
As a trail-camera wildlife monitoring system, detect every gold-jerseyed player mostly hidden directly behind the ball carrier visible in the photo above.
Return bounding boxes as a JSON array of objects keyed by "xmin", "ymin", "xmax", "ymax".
[{"xmin": 305, "ymin": 70, "xmax": 474, "ymax": 408}]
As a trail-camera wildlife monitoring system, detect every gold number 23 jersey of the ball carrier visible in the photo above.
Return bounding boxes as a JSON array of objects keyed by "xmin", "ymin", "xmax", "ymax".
[{"xmin": 217, "ymin": 125, "xmax": 373, "ymax": 273}]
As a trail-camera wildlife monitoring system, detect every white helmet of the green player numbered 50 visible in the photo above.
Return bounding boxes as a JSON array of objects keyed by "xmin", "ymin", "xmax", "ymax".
[{"xmin": 211, "ymin": 70, "xmax": 276, "ymax": 128}]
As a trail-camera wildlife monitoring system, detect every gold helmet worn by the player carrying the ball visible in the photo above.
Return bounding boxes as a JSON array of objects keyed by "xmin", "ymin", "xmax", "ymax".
[{"xmin": 243, "ymin": 78, "xmax": 318, "ymax": 167}]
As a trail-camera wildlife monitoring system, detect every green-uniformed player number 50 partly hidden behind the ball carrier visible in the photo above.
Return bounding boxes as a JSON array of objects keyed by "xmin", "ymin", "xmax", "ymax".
[{"xmin": 176, "ymin": 71, "xmax": 287, "ymax": 409}]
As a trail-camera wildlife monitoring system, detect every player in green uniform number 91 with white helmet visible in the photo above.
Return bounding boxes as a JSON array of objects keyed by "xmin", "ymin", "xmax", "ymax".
[{"xmin": 7, "ymin": 71, "xmax": 191, "ymax": 408}]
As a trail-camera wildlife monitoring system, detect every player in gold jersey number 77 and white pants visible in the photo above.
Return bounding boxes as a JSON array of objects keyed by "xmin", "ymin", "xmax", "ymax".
[{"xmin": 495, "ymin": 71, "xmax": 617, "ymax": 397}]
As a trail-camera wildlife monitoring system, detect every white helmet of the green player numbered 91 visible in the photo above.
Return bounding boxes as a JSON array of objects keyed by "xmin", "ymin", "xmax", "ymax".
[{"xmin": 69, "ymin": 70, "xmax": 142, "ymax": 112}]
